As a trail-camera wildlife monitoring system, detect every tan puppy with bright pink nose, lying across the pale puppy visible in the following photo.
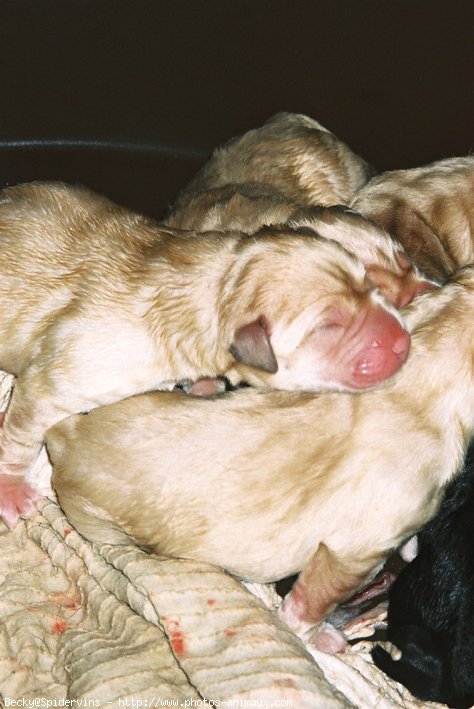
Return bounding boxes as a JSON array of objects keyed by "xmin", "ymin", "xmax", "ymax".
[{"xmin": 0, "ymin": 183, "xmax": 409, "ymax": 526}]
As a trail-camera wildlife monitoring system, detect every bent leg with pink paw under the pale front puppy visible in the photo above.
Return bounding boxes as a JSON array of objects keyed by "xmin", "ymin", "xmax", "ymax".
[{"xmin": 279, "ymin": 542, "xmax": 375, "ymax": 654}]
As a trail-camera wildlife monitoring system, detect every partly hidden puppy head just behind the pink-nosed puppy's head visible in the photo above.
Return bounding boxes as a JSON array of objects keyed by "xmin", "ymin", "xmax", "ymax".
[{"xmin": 290, "ymin": 205, "xmax": 438, "ymax": 308}]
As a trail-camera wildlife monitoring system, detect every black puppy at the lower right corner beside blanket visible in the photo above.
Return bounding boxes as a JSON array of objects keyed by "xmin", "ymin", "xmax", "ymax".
[{"xmin": 372, "ymin": 443, "xmax": 474, "ymax": 709}]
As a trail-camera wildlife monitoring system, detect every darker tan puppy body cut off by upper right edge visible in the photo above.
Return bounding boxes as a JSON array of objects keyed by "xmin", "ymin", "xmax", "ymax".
[{"xmin": 352, "ymin": 155, "xmax": 474, "ymax": 281}]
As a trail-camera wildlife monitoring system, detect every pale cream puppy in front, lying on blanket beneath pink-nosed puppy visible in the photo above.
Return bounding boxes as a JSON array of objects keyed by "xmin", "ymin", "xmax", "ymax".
[{"xmin": 46, "ymin": 269, "xmax": 474, "ymax": 650}]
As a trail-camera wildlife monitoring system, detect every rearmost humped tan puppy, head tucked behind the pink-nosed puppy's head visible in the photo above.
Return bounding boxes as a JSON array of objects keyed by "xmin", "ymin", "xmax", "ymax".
[{"xmin": 165, "ymin": 113, "xmax": 434, "ymax": 307}]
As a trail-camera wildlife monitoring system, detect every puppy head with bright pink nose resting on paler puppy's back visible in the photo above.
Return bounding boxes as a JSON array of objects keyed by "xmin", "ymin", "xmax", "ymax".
[{"xmin": 224, "ymin": 232, "xmax": 410, "ymax": 391}]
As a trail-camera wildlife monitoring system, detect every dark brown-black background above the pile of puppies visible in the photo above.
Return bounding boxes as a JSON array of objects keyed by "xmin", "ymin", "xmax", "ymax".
[{"xmin": 0, "ymin": 0, "xmax": 474, "ymax": 217}]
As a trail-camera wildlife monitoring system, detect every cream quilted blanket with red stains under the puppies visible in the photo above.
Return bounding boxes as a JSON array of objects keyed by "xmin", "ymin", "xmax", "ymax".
[{"xmin": 0, "ymin": 373, "xmax": 439, "ymax": 709}]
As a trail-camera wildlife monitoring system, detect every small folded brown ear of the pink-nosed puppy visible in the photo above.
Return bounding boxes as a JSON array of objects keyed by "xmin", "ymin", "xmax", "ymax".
[{"xmin": 230, "ymin": 315, "xmax": 278, "ymax": 374}]
